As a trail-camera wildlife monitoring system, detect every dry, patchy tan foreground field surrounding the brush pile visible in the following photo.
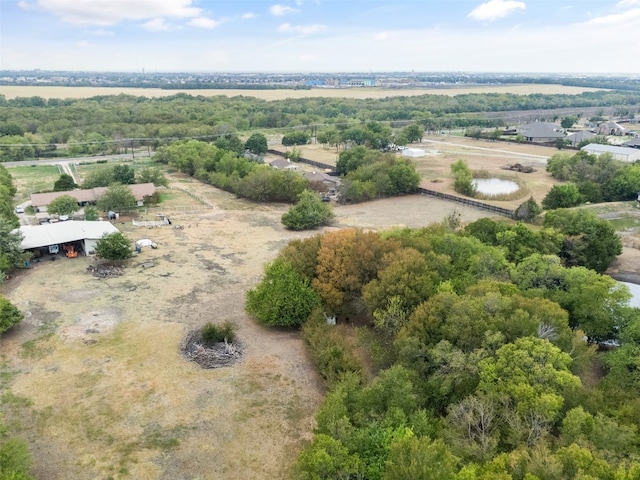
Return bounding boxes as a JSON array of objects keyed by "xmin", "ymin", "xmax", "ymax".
[{"xmin": 0, "ymin": 175, "xmax": 496, "ymax": 480}]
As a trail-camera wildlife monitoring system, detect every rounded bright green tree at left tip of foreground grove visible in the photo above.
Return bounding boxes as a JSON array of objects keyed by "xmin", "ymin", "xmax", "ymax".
[{"xmin": 245, "ymin": 259, "xmax": 320, "ymax": 327}]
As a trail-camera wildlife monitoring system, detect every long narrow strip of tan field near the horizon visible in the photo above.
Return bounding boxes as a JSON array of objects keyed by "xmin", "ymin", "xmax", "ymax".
[{"xmin": 0, "ymin": 84, "xmax": 599, "ymax": 100}]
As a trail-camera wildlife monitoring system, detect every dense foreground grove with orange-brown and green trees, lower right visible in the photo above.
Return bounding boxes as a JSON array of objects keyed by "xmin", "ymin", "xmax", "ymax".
[{"xmin": 247, "ymin": 221, "xmax": 640, "ymax": 480}]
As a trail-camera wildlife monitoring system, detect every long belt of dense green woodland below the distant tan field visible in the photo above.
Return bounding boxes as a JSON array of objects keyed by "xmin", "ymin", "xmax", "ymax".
[{"xmin": 0, "ymin": 91, "xmax": 640, "ymax": 161}]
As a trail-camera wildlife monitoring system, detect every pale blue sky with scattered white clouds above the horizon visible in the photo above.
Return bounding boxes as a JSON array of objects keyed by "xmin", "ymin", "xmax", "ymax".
[{"xmin": 0, "ymin": 0, "xmax": 640, "ymax": 74}]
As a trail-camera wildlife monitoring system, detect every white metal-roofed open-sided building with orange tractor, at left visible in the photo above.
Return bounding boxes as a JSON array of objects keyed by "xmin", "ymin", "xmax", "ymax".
[{"xmin": 19, "ymin": 220, "xmax": 119, "ymax": 256}]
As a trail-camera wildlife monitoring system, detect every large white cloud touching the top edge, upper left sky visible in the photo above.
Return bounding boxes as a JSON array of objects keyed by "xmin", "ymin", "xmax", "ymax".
[{"xmin": 25, "ymin": 0, "xmax": 202, "ymax": 26}]
